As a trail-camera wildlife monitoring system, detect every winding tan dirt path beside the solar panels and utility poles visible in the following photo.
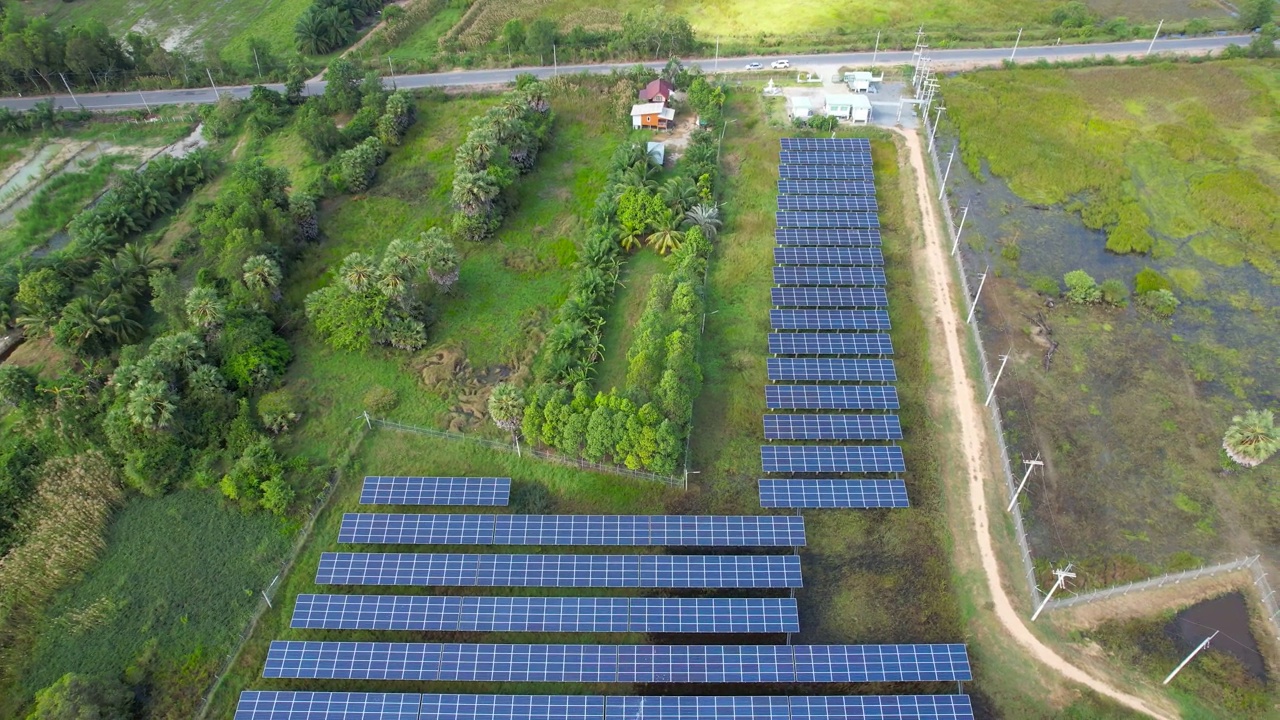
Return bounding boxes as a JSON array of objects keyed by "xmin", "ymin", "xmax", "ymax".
[{"xmin": 896, "ymin": 131, "xmax": 1172, "ymax": 717}]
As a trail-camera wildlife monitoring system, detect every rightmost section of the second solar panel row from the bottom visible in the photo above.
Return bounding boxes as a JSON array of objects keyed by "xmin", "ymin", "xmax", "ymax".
[{"xmin": 795, "ymin": 644, "xmax": 973, "ymax": 683}]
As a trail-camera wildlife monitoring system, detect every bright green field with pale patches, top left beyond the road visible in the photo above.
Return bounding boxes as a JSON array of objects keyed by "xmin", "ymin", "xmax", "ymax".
[{"xmin": 22, "ymin": 0, "xmax": 311, "ymax": 59}]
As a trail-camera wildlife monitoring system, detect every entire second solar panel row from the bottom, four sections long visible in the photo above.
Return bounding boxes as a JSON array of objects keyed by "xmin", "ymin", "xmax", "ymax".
[{"xmin": 262, "ymin": 641, "xmax": 972, "ymax": 683}]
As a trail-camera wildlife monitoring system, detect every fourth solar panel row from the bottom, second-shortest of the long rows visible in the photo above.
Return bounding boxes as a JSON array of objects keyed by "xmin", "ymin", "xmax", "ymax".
[{"xmin": 316, "ymin": 552, "xmax": 801, "ymax": 588}]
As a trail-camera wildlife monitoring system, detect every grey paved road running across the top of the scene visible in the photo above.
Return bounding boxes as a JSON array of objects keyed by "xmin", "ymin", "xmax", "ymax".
[{"xmin": 0, "ymin": 35, "xmax": 1251, "ymax": 110}]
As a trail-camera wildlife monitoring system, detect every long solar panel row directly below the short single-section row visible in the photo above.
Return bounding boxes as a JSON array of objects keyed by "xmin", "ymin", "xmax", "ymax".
[{"xmin": 338, "ymin": 512, "xmax": 804, "ymax": 547}]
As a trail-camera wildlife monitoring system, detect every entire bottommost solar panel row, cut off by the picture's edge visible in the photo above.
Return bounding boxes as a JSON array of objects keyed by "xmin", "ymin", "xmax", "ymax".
[{"xmin": 234, "ymin": 691, "xmax": 973, "ymax": 720}]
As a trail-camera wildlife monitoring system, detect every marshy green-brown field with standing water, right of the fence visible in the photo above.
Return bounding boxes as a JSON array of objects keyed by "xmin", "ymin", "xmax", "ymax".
[{"xmin": 943, "ymin": 61, "xmax": 1280, "ymax": 589}]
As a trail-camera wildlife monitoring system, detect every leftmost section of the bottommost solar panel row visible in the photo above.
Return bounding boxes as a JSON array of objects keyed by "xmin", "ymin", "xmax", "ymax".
[{"xmin": 234, "ymin": 691, "xmax": 422, "ymax": 720}]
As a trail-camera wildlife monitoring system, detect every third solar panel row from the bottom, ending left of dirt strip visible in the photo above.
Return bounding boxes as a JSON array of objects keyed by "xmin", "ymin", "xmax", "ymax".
[{"xmin": 289, "ymin": 594, "xmax": 800, "ymax": 633}]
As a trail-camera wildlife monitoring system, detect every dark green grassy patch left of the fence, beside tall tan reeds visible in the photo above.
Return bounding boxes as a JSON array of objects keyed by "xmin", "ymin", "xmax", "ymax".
[{"xmin": 10, "ymin": 491, "xmax": 289, "ymax": 716}]
